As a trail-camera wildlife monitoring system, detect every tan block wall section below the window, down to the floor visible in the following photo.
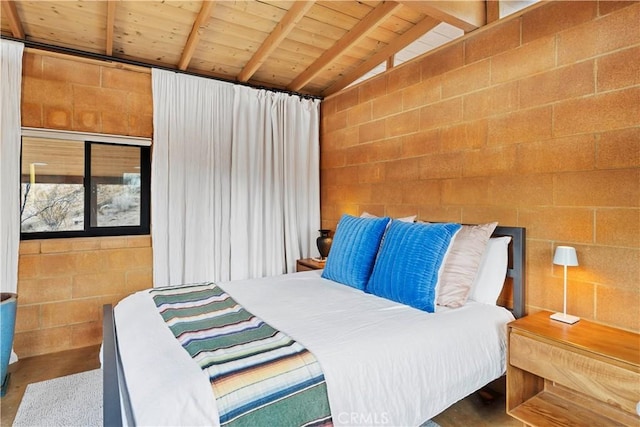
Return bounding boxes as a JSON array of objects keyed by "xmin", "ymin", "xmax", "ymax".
[{"xmin": 14, "ymin": 236, "xmax": 152, "ymax": 357}]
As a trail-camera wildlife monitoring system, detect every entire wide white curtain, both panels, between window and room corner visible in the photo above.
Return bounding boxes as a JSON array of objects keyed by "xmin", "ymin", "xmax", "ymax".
[{"xmin": 151, "ymin": 70, "xmax": 320, "ymax": 286}]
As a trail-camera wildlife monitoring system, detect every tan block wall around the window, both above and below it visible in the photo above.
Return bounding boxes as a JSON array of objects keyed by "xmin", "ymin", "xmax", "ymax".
[{"xmin": 14, "ymin": 49, "xmax": 153, "ymax": 357}]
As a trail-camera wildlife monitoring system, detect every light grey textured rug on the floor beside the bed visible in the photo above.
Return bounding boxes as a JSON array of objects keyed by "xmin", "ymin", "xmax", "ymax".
[{"xmin": 13, "ymin": 369, "xmax": 102, "ymax": 427}]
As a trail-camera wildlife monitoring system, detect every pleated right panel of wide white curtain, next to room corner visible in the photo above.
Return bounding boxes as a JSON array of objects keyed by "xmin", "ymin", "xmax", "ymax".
[{"xmin": 231, "ymin": 86, "xmax": 320, "ymax": 278}]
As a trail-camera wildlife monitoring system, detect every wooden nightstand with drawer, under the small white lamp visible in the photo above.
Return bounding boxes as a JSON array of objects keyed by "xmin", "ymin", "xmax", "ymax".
[{"xmin": 507, "ymin": 311, "xmax": 640, "ymax": 427}]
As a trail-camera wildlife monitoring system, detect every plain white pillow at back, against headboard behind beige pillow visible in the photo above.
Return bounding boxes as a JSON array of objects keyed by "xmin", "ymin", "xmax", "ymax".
[{"xmin": 469, "ymin": 236, "xmax": 511, "ymax": 305}]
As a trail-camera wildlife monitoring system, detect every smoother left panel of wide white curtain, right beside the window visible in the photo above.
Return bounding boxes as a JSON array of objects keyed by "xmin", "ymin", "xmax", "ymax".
[{"xmin": 151, "ymin": 69, "xmax": 233, "ymax": 286}]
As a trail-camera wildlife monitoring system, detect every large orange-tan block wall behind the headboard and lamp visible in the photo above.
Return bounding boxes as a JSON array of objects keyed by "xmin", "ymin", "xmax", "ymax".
[{"xmin": 321, "ymin": 1, "xmax": 640, "ymax": 331}]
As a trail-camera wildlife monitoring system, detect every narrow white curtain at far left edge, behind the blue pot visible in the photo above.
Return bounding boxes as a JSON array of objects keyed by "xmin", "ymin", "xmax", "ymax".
[{"xmin": 0, "ymin": 40, "xmax": 24, "ymax": 293}]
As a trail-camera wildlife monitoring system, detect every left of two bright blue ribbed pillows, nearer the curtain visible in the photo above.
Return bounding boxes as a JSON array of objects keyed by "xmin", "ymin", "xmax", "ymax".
[{"xmin": 322, "ymin": 214, "xmax": 389, "ymax": 290}]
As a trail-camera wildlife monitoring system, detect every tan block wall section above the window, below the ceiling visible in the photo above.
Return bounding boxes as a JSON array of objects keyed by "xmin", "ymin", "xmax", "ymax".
[{"xmin": 21, "ymin": 49, "xmax": 153, "ymax": 137}]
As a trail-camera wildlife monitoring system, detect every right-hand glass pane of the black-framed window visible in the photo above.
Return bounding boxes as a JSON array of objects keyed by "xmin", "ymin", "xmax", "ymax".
[{"xmin": 91, "ymin": 143, "xmax": 141, "ymax": 227}]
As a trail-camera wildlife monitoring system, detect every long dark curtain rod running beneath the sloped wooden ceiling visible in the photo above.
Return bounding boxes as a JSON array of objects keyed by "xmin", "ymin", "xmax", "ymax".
[{"xmin": 0, "ymin": 35, "xmax": 324, "ymax": 100}]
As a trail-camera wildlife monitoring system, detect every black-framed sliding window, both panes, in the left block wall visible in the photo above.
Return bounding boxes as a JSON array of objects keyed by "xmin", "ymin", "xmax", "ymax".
[{"xmin": 20, "ymin": 135, "xmax": 150, "ymax": 239}]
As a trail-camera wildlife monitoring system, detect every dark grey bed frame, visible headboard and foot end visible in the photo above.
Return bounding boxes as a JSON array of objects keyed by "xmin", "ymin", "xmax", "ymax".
[{"xmin": 102, "ymin": 226, "xmax": 526, "ymax": 427}]
